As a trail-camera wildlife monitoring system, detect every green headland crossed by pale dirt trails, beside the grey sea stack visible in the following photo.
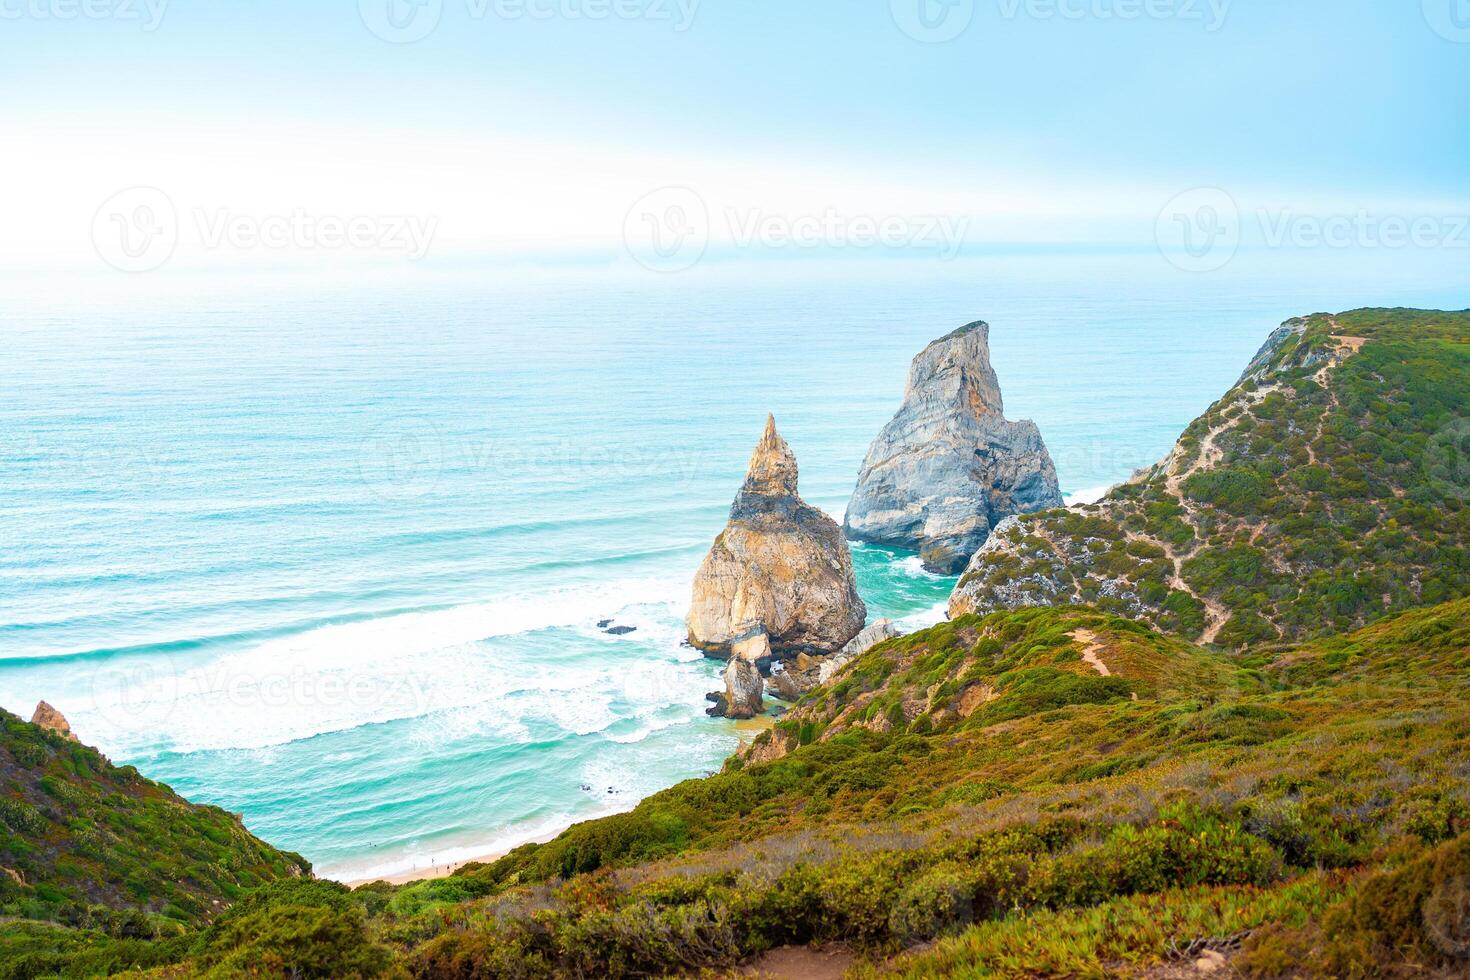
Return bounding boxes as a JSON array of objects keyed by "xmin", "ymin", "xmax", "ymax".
[{"xmin": 951, "ymin": 310, "xmax": 1470, "ymax": 648}]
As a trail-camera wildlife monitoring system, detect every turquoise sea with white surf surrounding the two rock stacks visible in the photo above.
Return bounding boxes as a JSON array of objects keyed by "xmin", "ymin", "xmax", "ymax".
[{"xmin": 0, "ymin": 256, "xmax": 1470, "ymax": 877}]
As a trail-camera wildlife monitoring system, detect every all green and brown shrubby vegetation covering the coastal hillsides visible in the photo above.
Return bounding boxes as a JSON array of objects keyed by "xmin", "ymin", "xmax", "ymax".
[{"xmin": 0, "ymin": 311, "xmax": 1470, "ymax": 980}]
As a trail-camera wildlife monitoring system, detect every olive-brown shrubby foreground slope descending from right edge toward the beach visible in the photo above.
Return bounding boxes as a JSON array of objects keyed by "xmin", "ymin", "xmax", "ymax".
[{"xmin": 100, "ymin": 599, "xmax": 1470, "ymax": 977}]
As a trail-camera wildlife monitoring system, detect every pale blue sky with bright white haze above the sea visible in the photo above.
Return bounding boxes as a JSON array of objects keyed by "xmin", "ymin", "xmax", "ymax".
[{"xmin": 0, "ymin": 0, "xmax": 1470, "ymax": 272}]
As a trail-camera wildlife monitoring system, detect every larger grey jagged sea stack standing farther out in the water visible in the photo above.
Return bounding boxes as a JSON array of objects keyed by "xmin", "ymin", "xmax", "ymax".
[{"xmin": 845, "ymin": 322, "xmax": 1061, "ymax": 574}]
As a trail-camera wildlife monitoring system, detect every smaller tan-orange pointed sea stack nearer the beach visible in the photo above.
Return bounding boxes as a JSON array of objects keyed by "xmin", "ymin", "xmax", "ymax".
[{"xmin": 688, "ymin": 419, "xmax": 867, "ymax": 658}]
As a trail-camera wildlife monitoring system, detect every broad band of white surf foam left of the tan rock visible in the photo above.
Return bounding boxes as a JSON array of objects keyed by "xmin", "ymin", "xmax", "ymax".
[{"xmin": 78, "ymin": 579, "xmax": 698, "ymax": 757}]
